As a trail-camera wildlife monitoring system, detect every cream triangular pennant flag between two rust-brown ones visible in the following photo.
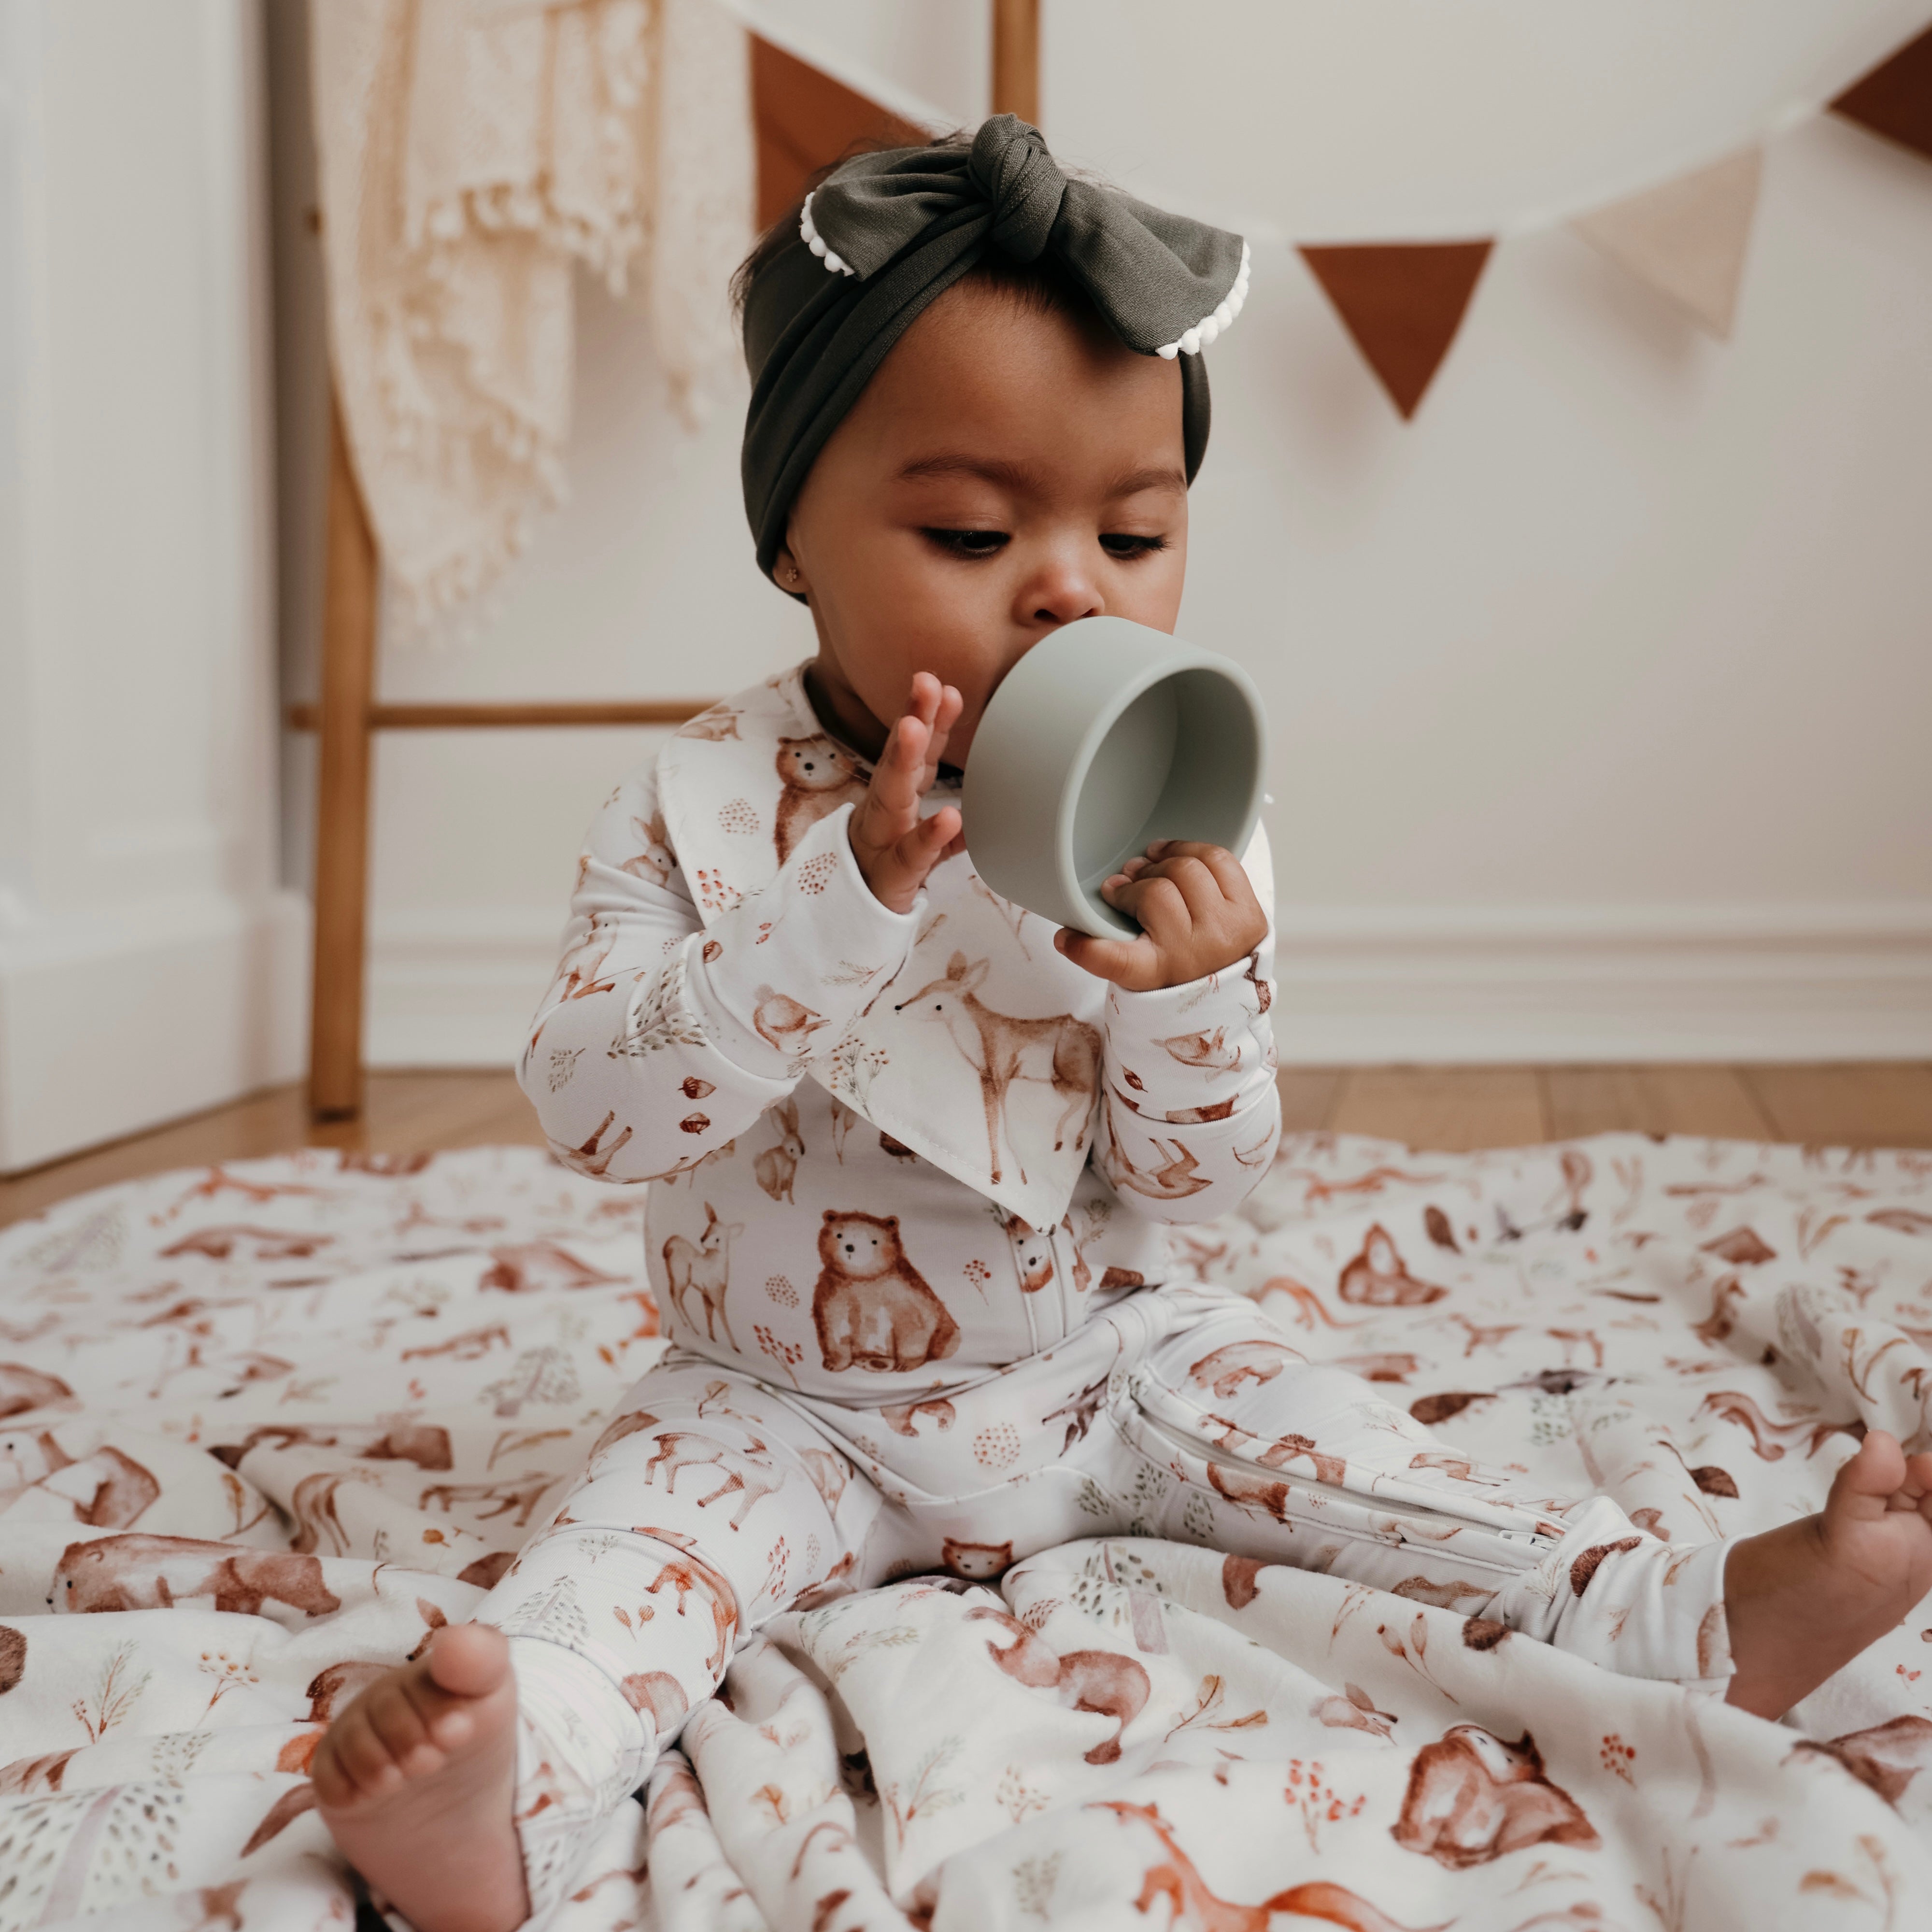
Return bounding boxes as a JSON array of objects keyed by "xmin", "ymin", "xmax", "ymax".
[{"xmin": 1571, "ymin": 147, "xmax": 1764, "ymax": 338}]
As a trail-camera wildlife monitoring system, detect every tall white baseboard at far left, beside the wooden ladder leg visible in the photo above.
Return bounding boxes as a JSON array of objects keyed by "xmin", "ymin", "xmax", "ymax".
[{"xmin": 0, "ymin": 891, "xmax": 309, "ymax": 1175}]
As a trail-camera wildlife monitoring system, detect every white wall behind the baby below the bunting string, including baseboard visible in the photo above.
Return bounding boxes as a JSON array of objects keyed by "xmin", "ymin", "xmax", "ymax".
[{"xmin": 272, "ymin": 19, "xmax": 1932, "ymax": 1063}]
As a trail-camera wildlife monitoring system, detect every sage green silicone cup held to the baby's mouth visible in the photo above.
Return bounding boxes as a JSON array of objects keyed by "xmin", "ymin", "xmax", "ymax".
[{"xmin": 960, "ymin": 616, "xmax": 1267, "ymax": 939}]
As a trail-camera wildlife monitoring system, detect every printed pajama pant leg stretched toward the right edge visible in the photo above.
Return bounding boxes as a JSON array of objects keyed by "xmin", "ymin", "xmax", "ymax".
[{"xmin": 1117, "ymin": 1300, "xmax": 1731, "ymax": 1690}]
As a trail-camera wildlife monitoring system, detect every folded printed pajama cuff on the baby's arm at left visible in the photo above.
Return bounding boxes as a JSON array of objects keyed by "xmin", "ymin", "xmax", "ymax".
[{"xmin": 684, "ymin": 806, "xmax": 925, "ymax": 1082}]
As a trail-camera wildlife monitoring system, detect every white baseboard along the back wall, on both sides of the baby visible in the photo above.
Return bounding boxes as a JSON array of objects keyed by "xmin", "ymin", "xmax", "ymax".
[{"xmin": 369, "ymin": 902, "xmax": 1932, "ymax": 1066}]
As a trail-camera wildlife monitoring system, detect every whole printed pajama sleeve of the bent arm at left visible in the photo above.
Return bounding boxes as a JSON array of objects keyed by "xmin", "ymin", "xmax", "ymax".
[{"xmin": 518, "ymin": 750, "xmax": 925, "ymax": 1182}]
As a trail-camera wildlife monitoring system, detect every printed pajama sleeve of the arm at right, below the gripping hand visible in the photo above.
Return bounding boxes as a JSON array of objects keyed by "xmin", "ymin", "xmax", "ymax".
[{"xmin": 1094, "ymin": 831, "xmax": 1281, "ymax": 1221}]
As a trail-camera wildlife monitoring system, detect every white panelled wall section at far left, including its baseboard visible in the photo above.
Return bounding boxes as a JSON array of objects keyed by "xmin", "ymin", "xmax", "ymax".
[{"xmin": 0, "ymin": 0, "xmax": 305, "ymax": 1171}]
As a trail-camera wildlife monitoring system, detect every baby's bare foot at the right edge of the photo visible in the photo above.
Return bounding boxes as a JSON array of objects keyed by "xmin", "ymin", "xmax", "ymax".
[{"xmin": 1723, "ymin": 1430, "xmax": 1932, "ymax": 1718}]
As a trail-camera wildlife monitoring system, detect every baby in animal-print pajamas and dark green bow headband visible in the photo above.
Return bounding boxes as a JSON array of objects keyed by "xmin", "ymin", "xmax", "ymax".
[{"xmin": 315, "ymin": 116, "xmax": 1932, "ymax": 1932}]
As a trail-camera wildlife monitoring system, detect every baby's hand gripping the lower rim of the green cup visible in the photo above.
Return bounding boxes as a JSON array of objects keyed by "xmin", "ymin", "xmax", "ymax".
[{"xmin": 1053, "ymin": 838, "xmax": 1267, "ymax": 993}]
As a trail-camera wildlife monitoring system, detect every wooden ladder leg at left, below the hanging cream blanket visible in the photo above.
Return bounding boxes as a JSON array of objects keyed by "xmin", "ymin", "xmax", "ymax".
[{"xmin": 309, "ymin": 381, "xmax": 377, "ymax": 1121}]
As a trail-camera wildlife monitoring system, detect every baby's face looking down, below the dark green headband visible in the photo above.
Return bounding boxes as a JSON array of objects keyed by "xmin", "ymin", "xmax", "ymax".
[{"xmin": 779, "ymin": 280, "xmax": 1188, "ymax": 765}]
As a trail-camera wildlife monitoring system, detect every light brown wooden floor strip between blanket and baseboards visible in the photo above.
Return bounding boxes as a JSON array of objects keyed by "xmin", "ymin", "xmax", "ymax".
[{"xmin": 0, "ymin": 1061, "xmax": 1932, "ymax": 1227}]
